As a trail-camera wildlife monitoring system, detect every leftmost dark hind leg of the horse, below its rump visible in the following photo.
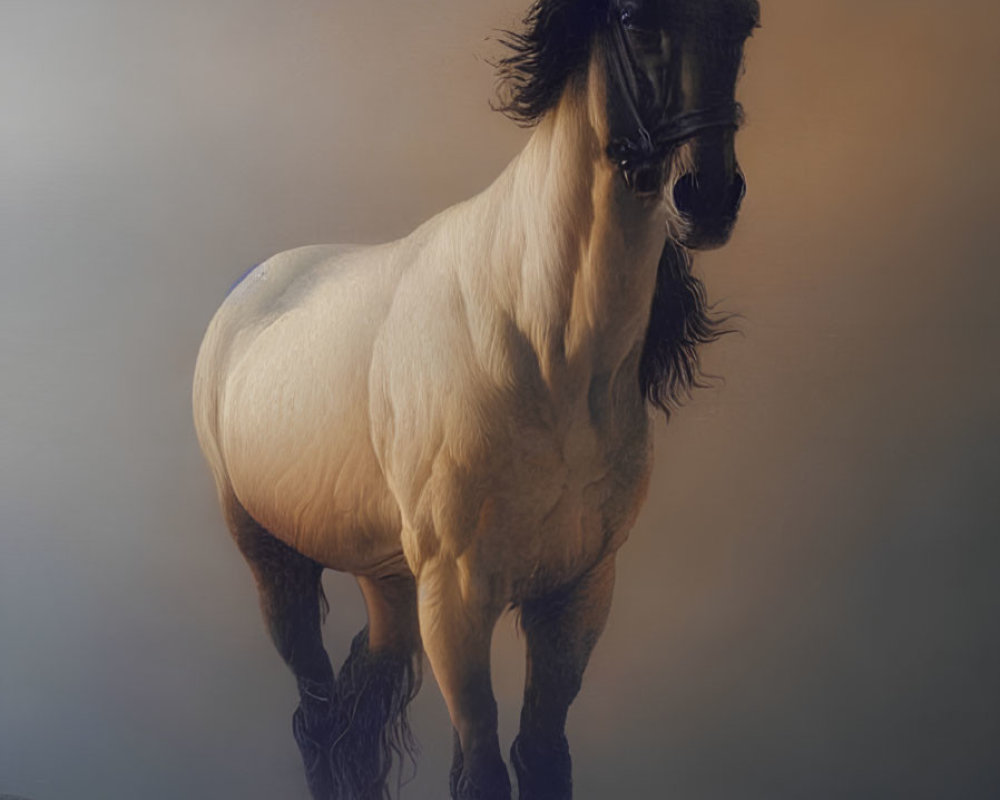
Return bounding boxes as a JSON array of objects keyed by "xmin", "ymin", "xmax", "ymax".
[{"xmin": 226, "ymin": 498, "xmax": 338, "ymax": 800}]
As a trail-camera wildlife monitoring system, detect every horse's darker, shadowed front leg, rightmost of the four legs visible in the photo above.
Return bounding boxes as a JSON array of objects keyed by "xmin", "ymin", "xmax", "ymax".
[{"xmin": 511, "ymin": 555, "xmax": 615, "ymax": 800}]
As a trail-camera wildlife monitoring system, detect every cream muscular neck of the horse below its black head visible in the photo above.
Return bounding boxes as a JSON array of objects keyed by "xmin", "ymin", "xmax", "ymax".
[{"xmin": 494, "ymin": 66, "xmax": 666, "ymax": 392}]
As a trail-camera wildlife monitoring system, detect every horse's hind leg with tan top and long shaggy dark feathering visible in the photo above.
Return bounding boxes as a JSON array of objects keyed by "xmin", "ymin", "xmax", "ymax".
[{"xmin": 331, "ymin": 574, "xmax": 421, "ymax": 800}]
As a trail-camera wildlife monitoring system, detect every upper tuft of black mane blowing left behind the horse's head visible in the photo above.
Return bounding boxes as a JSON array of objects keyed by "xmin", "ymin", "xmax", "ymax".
[{"xmin": 496, "ymin": 0, "xmax": 607, "ymax": 126}]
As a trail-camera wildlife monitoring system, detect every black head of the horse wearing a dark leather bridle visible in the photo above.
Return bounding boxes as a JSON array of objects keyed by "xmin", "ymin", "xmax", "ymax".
[{"xmin": 596, "ymin": 0, "xmax": 760, "ymax": 249}]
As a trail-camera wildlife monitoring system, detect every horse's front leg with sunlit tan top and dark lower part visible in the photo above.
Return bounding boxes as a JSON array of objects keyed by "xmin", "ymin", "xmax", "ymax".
[{"xmin": 418, "ymin": 557, "xmax": 511, "ymax": 800}]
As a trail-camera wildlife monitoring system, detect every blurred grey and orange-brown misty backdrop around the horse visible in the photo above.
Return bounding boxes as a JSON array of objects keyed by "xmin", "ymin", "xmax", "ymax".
[{"xmin": 0, "ymin": 0, "xmax": 1000, "ymax": 800}]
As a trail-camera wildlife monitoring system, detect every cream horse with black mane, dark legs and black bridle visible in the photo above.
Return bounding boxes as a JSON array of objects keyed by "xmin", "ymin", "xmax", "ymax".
[{"xmin": 193, "ymin": 0, "xmax": 759, "ymax": 800}]
